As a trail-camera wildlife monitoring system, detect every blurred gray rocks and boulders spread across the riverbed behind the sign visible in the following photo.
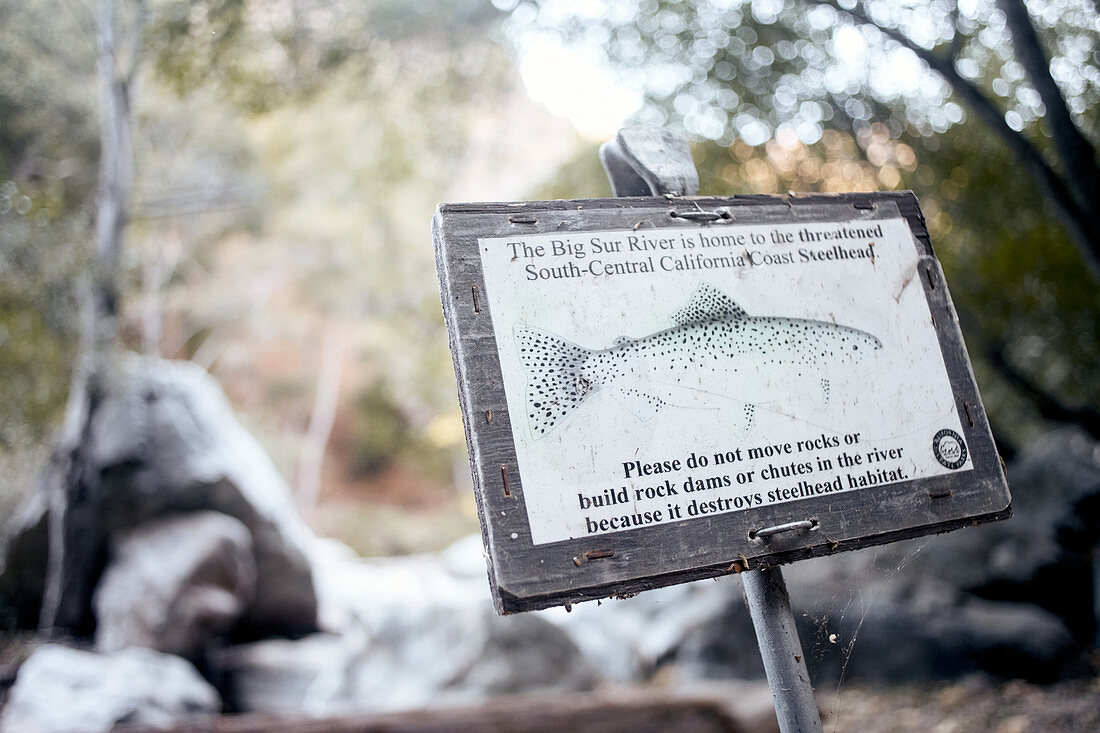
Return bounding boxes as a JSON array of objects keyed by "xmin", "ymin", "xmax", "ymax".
[{"xmin": 0, "ymin": 359, "xmax": 1100, "ymax": 733}]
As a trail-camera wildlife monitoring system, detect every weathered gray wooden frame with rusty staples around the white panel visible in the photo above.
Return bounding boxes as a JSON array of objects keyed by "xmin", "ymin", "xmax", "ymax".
[{"xmin": 433, "ymin": 192, "xmax": 1011, "ymax": 613}]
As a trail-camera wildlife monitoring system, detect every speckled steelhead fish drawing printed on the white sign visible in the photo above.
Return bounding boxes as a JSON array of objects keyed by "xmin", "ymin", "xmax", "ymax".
[{"xmin": 513, "ymin": 283, "xmax": 882, "ymax": 439}]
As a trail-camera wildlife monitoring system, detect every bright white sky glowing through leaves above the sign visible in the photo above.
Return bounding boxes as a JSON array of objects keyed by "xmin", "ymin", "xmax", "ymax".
[{"xmin": 506, "ymin": 0, "xmax": 1082, "ymax": 145}]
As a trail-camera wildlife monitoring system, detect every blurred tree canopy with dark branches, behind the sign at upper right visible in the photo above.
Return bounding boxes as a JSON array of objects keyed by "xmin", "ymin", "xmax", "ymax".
[{"xmin": 510, "ymin": 0, "xmax": 1100, "ymax": 451}]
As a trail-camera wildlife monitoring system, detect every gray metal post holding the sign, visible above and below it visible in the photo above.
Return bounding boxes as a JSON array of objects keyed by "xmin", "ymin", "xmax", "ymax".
[{"xmin": 600, "ymin": 127, "xmax": 822, "ymax": 733}]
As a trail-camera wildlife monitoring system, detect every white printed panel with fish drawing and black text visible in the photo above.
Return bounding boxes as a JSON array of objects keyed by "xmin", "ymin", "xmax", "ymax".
[{"xmin": 477, "ymin": 218, "xmax": 972, "ymax": 545}]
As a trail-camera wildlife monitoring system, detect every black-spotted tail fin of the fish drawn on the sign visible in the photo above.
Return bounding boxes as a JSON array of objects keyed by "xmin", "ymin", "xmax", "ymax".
[{"xmin": 512, "ymin": 324, "xmax": 598, "ymax": 440}]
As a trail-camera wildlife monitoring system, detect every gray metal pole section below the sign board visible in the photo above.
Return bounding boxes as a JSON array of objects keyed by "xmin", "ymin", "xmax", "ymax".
[{"xmin": 740, "ymin": 568, "xmax": 822, "ymax": 733}]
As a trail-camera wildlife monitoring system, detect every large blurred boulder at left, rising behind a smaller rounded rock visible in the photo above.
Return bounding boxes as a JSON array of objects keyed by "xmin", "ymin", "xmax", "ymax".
[{"xmin": 0, "ymin": 355, "xmax": 317, "ymax": 637}]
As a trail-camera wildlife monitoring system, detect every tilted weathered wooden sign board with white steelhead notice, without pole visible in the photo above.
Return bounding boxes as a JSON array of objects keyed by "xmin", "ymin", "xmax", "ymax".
[{"xmin": 435, "ymin": 193, "xmax": 1010, "ymax": 612}]
